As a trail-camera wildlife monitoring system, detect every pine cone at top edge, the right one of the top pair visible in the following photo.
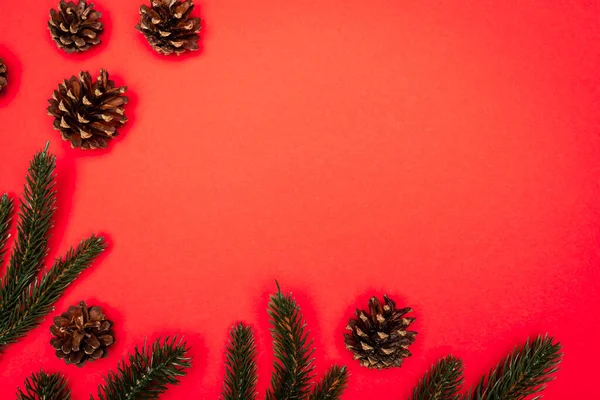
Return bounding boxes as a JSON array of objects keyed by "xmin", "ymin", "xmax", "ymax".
[{"xmin": 135, "ymin": 0, "xmax": 200, "ymax": 55}]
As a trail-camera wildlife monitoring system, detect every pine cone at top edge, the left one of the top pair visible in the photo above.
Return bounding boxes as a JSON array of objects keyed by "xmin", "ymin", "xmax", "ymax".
[{"xmin": 48, "ymin": 0, "xmax": 103, "ymax": 53}]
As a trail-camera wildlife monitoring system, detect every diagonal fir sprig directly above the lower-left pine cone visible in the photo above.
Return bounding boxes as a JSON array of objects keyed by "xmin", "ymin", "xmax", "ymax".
[{"xmin": 0, "ymin": 236, "xmax": 106, "ymax": 351}]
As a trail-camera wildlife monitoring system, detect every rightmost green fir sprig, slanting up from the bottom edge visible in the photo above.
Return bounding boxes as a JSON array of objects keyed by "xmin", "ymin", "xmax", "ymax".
[{"xmin": 466, "ymin": 335, "xmax": 562, "ymax": 400}]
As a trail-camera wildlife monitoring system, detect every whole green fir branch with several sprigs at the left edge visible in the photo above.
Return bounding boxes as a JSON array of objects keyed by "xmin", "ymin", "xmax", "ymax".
[{"xmin": 0, "ymin": 146, "xmax": 106, "ymax": 353}]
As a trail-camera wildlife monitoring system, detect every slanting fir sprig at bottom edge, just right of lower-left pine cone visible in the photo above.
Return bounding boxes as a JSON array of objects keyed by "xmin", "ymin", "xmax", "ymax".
[{"xmin": 98, "ymin": 337, "xmax": 191, "ymax": 400}]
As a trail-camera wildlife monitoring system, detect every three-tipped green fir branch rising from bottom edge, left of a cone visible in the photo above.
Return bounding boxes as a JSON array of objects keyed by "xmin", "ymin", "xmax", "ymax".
[{"xmin": 221, "ymin": 286, "xmax": 348, "ymax": 400}]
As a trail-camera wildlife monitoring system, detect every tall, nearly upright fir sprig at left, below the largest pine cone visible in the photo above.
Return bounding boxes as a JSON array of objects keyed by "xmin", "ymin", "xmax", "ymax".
[{"xmin": 0, "ymin": 145, "xmax": 56, "ymax": 310}]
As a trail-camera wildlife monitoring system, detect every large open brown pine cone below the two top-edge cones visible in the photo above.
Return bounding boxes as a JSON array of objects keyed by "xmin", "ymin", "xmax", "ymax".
[{"xmin": 48, "ymin": 69, "xmax": 128, "ymax": 149}]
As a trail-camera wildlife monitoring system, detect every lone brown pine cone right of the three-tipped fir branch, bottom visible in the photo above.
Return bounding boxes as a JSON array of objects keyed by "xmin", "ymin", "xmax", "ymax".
[{"xmin": 344, "ymin": 295, "xmax": 417, "ymax": 369}]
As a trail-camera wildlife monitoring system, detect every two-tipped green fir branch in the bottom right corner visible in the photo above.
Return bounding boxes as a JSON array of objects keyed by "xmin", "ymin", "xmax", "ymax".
[{"xmin": 409, "ymin": 335, "xmax": 562, "ymax": 400}]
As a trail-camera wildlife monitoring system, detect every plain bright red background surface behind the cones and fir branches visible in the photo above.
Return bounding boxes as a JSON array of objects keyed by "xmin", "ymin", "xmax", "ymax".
[{"xmin": 0, "ymin": 0, "xmax": 600, "ymax": 400}]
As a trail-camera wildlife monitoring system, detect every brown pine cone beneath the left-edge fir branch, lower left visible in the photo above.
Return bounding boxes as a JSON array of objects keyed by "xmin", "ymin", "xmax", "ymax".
[{"xmin": 50, "ymin": 301, "xmax": 115, "ymax": 367}]
